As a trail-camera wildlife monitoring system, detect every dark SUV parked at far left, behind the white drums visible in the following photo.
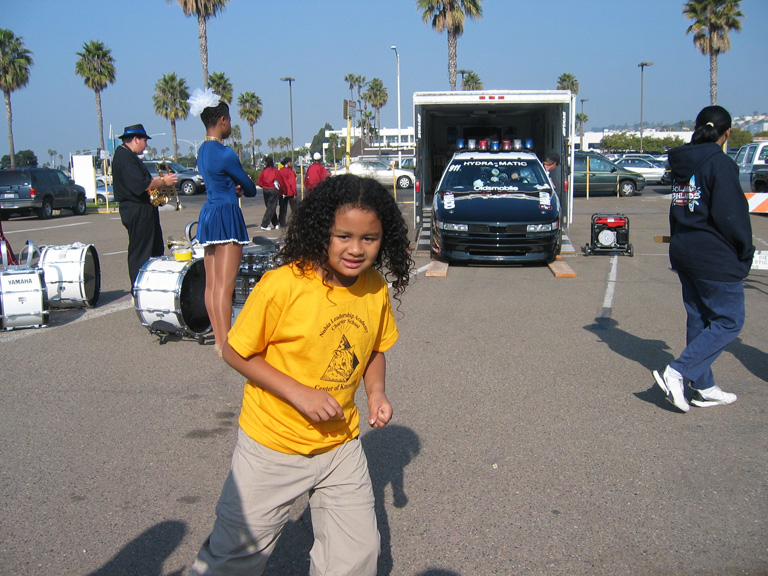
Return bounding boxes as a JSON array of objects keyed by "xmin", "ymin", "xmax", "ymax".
[{"xmin": 0, "ymin": 168, "xmax": 86, "ymax": 219}]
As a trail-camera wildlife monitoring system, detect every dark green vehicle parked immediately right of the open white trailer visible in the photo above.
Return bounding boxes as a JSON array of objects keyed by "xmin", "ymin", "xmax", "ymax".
[{"xmin": 573, "ymin": 151, "xmax": 645, "ymax": 196}]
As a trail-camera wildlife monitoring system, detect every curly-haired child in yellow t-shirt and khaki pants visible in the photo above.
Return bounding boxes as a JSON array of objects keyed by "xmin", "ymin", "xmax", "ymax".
[{"xmin": 190, "ymin": 175, "xmax": 413, "ymax": 576}]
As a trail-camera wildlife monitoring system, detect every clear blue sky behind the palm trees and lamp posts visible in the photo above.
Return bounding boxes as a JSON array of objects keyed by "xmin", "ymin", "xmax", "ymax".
[{"xmin": 0, "ymin": 0, "xmax": 768, "ymax": 162}]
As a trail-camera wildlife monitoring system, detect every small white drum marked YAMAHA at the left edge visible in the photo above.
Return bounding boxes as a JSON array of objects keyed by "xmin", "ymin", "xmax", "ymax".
[{"xmin": 0, "ymin": 268, "xmax": 49, "ymax": 330}]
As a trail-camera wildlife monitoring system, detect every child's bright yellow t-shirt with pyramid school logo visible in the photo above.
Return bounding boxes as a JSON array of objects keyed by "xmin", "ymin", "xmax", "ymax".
[{"xmin": 229, "ymin": 266, "xmax": 398, "ymax": 454}]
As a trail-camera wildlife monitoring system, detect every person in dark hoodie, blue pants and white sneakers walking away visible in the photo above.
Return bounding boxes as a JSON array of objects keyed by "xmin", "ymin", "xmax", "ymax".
[{"xmin": 653, "ymin": 106, "xmax": 755, "ymax": 412}]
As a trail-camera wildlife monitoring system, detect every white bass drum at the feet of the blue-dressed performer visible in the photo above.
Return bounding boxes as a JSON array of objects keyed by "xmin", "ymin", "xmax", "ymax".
[{"xmin": 133, "ymin": 256, "xmax": 211, "ymax": 339}]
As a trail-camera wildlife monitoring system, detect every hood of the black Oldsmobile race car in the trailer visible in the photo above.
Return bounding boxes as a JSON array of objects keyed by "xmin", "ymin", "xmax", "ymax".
[{"xmin": 437, "ymin": 191, "xmax": 559, "ymax": 223}]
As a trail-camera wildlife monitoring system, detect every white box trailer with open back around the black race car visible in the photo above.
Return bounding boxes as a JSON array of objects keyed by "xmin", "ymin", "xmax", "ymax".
[{"xmin": 413, "ymin": 90, "xmax": 576, "ymax": 229}]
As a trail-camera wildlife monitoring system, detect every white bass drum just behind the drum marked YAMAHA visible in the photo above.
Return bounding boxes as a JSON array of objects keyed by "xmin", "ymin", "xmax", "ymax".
[{"xmin": 38, "ymin": 243, "xmax": 101, "ymax": 308}]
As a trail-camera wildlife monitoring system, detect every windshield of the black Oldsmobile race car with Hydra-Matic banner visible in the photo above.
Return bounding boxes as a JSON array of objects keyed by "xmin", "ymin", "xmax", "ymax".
[{"xmin": 440, "ymin": 158, "xmax": 549, "ymax": 193}]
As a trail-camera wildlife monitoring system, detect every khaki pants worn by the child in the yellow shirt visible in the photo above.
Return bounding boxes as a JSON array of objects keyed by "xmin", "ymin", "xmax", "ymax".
[{"xmin": 190, "ymin": 430, "xmax": 379, "ymax": 576}]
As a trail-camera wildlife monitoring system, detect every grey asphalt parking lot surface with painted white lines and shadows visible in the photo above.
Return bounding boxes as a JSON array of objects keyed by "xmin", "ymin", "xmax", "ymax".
[{"xmin": 0, "ymin": 187, "xmax": 768, "ymax": 576}]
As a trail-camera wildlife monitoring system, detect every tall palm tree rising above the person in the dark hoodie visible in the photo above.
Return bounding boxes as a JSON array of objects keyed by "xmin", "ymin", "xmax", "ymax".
[{"xmin": 683, "ymin": 0, "xmax": 744, "ymax": 106}]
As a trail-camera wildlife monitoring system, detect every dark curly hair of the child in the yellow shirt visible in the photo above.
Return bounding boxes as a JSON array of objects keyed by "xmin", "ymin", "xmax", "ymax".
[{"xmin": 277, "ymin": 174, "xmax": 414, "ymax": 301}]
